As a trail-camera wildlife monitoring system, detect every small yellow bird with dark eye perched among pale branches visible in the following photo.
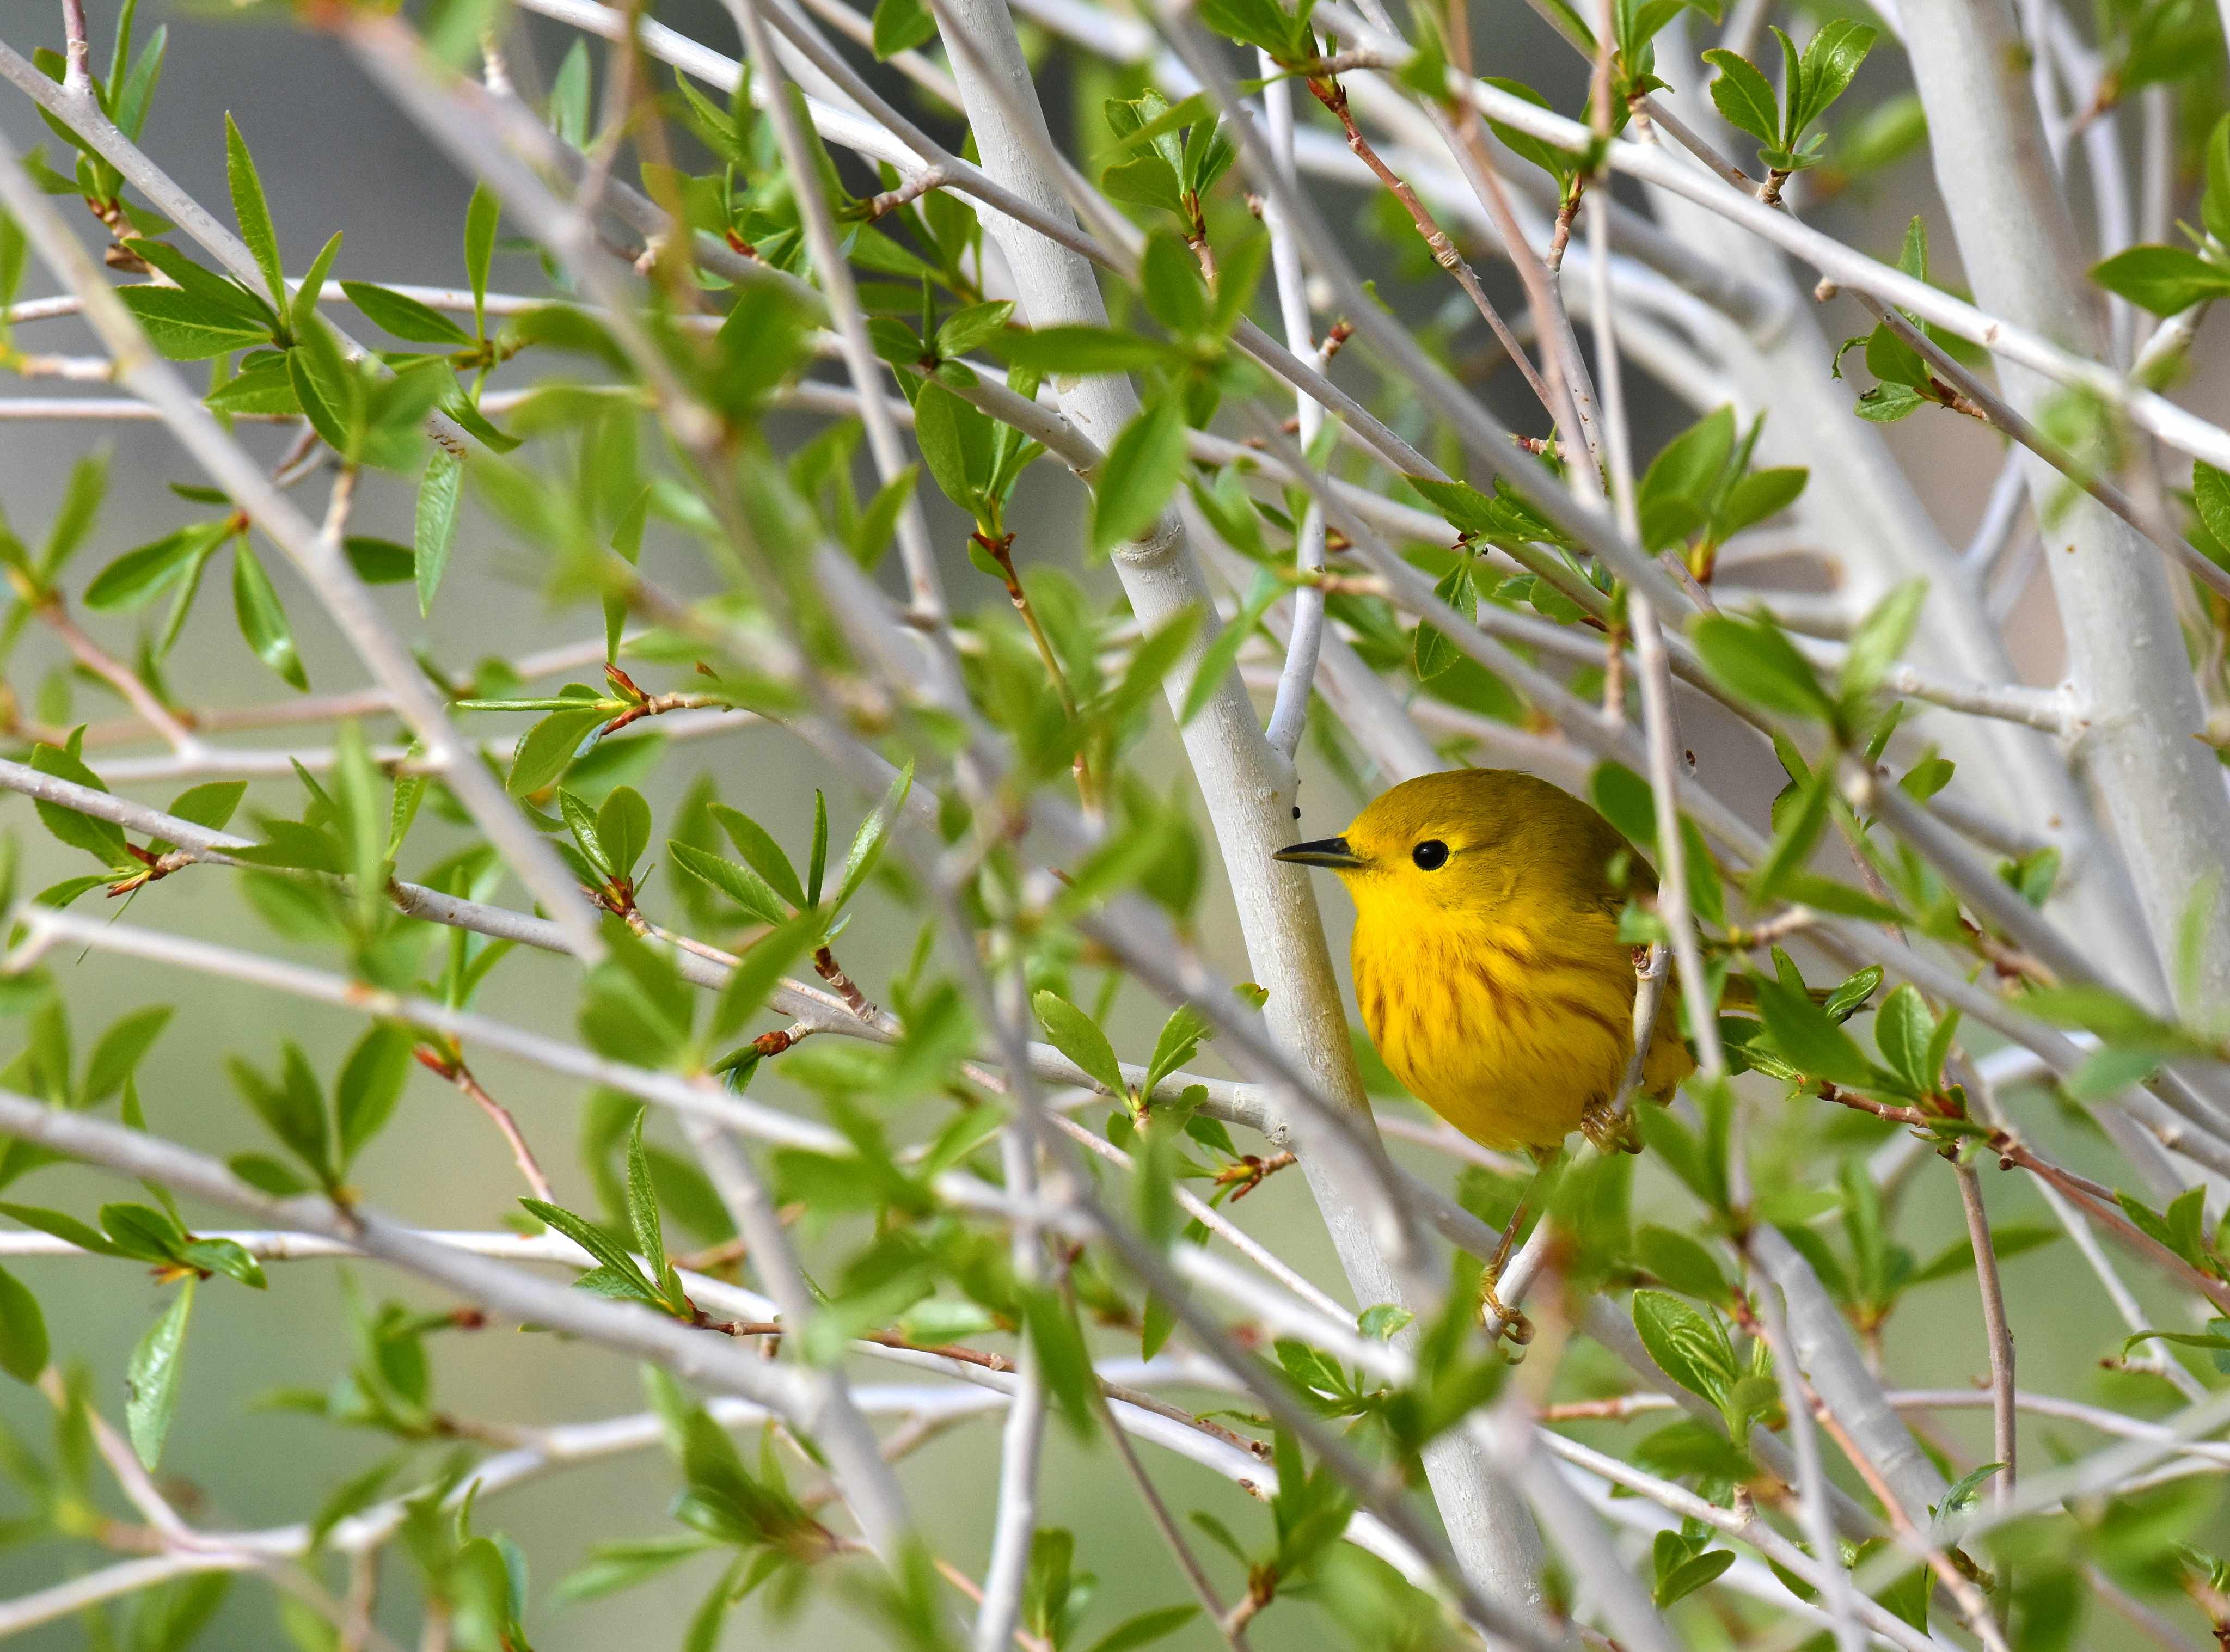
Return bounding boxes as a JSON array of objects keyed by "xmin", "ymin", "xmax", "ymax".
[{"xmin": 1280, "ymin": 769, "xmax": 1695, "ymax": 1148}]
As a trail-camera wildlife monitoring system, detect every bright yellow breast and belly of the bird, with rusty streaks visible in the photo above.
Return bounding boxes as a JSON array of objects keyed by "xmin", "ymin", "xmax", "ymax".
[{"xmin": 1351, "ymin": 899, "xmax": 1690, "ymax": 1148}]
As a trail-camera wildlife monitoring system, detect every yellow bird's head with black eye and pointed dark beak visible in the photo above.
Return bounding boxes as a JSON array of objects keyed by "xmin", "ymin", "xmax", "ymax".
[{"xmin": 1278, "ymin": 769, "xmax": 1655, "ymax": 912}]
